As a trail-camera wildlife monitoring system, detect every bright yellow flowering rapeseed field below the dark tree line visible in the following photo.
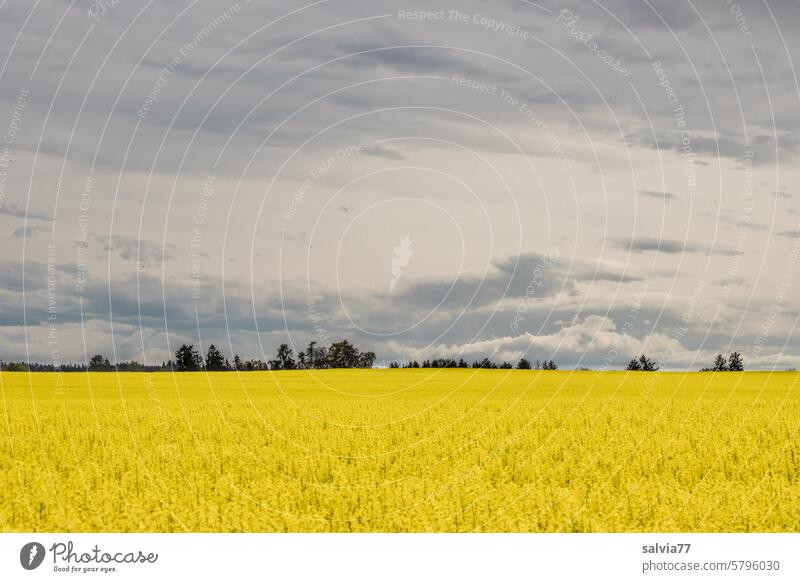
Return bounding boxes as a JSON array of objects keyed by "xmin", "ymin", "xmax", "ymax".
[{"xmin": 0, "ymin": 369, "xmax": 800, "ymax": 532}]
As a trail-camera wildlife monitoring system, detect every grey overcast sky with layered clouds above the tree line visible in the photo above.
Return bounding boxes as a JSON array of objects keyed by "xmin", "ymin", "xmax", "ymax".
[{"xmin": 0, "ymin": 0, "xmax": 800, "ymax": 369}]
